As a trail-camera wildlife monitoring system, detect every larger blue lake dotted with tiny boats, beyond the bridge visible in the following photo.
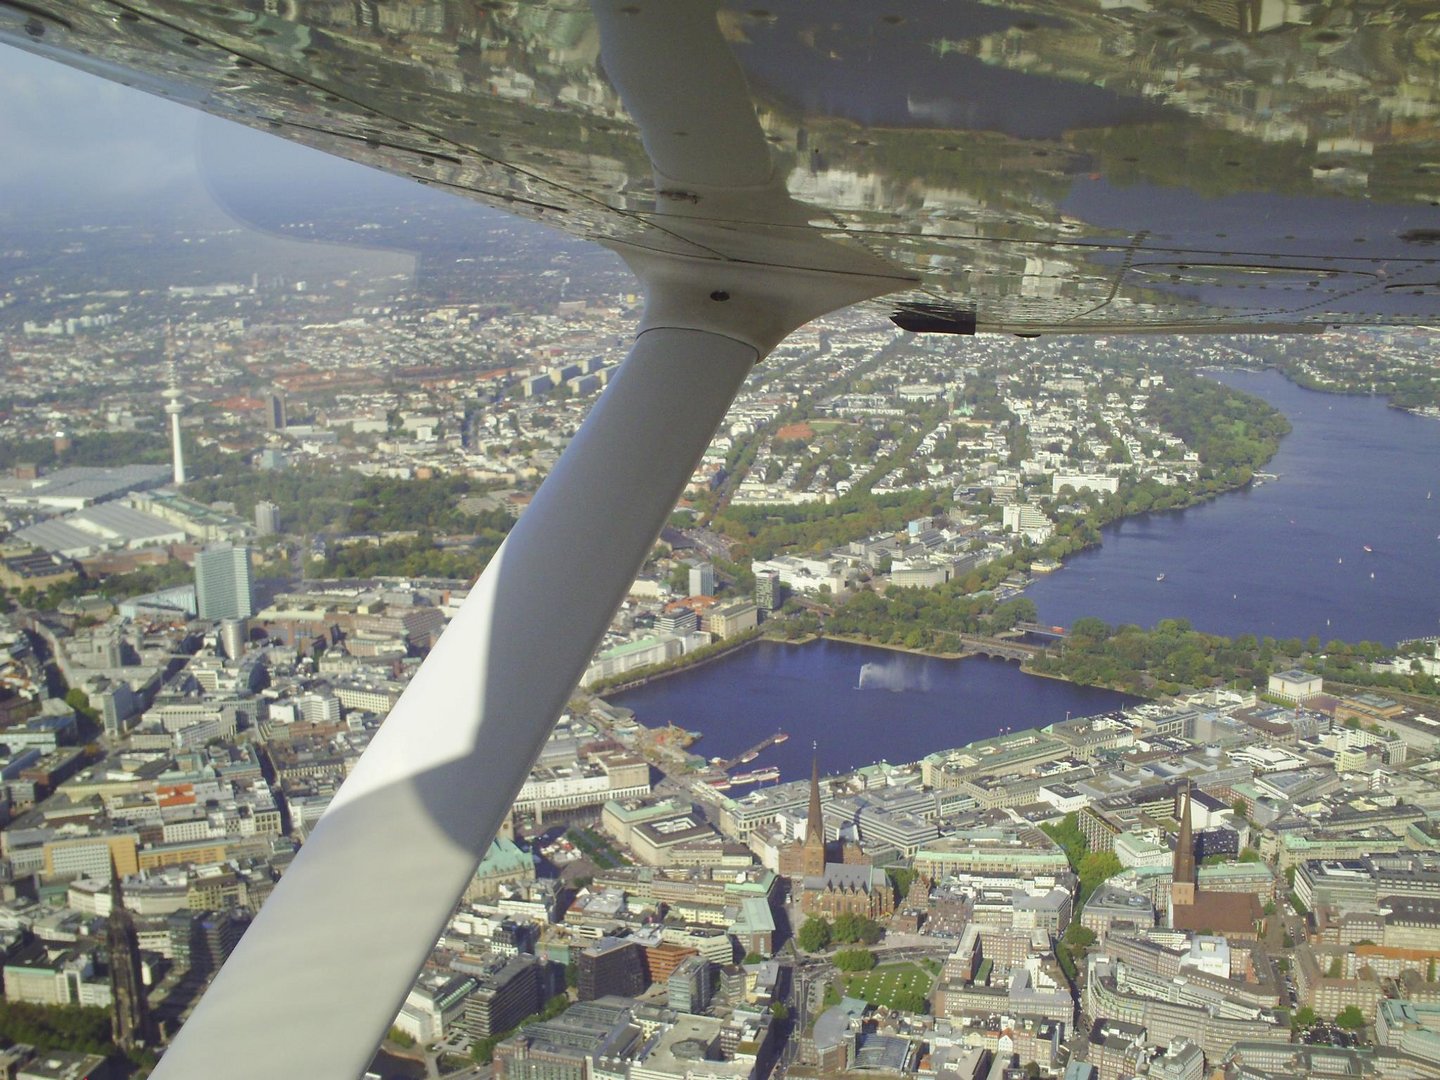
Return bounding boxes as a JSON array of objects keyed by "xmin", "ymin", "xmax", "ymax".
[{"xmin": 1025, "ymin": 372, "xmax": 1440, "ymax": 644}]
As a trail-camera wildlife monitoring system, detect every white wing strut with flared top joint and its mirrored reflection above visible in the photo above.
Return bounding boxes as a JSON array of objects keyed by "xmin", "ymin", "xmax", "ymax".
[{"xmin": 154, "ymin": 0, "xmax": 913, "ymax": 1080}]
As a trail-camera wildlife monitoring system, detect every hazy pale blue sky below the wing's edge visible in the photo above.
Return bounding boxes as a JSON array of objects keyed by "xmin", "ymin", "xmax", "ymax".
[{"xmin": 0, "ymin": 45, "xmax": 383, "ymax": 210}]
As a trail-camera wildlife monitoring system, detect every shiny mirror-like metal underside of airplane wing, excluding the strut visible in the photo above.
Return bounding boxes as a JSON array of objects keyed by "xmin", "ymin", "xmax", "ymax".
[{"xmin": 0, "ymin": 0, "xmax": 1440, "ymax": 334}]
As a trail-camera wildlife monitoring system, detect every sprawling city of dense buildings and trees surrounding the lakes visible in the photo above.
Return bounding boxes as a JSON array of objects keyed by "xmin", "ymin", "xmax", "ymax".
[{"xmin": 0, "ymin": 131, "xmax": 1440, "ymax": 1080}]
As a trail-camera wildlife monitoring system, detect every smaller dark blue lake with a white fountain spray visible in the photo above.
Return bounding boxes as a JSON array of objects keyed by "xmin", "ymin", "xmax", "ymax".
[{"xmin": 611, "ymin": 641, "xmax": 1133, "ymax": 793}]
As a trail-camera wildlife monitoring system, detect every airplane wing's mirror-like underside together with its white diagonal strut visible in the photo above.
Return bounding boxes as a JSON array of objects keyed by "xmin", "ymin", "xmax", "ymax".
[{"xmin": 0, "ymin": 0, "xmax": 1440, "ymax": 1080}]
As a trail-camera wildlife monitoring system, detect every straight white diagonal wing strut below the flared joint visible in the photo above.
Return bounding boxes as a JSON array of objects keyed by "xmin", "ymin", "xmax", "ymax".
[{"xmin": 156, "ymin": 319, "xmax": 757, "ymax": 1080}]
